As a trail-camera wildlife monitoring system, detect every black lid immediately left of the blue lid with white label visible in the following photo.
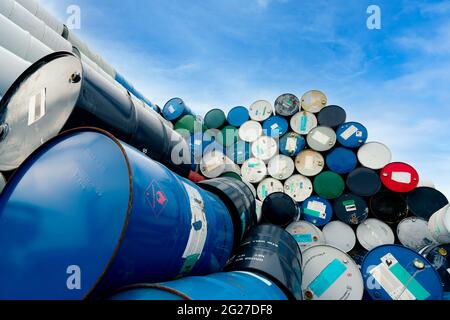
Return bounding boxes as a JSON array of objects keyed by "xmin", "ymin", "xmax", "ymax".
[{"xmin": 261, "ymin": 192, "xmax": 300, "ymax": 227}]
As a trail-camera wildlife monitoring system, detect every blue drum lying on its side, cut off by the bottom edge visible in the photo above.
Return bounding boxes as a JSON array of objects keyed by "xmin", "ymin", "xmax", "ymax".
[{"xmin": 111, "ymin": 271, "xmax": 287, "ymax": 301}]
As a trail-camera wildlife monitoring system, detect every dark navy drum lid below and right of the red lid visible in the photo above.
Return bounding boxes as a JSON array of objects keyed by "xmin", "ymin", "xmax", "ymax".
[{"xmin": 406, "ymin": 187, "xmax": 449, "ymax": 220}]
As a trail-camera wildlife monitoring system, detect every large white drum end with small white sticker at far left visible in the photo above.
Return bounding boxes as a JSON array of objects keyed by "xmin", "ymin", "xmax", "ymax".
[{"xmin": 0, "ymin": 52, "xmax": 84, "ymax": 171}]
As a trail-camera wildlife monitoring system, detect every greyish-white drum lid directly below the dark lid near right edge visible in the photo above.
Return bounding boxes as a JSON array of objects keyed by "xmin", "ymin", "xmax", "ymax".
[{"xmin": 397, "ymin": 217, "xmax": 435, "ymax": 252}]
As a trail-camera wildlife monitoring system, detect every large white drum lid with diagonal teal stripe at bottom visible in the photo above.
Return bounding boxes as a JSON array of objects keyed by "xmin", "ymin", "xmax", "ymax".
[{"xmin": 302, "ymin": 246, "xmax": 364, "ymax": 300}]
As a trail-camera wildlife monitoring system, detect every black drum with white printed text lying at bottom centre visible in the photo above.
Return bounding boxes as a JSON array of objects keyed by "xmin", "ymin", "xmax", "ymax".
[{"xmin": 225, "ymin": 224, "xmax": 303, "ymax": 300}]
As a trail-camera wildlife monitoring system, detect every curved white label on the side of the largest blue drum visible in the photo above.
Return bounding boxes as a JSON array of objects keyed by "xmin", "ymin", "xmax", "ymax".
[{"xmin": 180, "ymin": 182, "xmax": 208, "ymax": 275}]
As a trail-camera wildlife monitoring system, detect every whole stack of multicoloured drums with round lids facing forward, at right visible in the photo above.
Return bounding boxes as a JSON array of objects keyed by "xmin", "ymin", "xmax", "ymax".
[{"xmin": 157, "ymin": 90, "xmax": 450, "ymax": 300}]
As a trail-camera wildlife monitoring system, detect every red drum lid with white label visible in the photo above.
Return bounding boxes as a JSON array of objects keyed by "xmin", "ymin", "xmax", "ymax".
[{"xmin": 380, "ymin": 162, "xmax": 419, "ymax": 193}]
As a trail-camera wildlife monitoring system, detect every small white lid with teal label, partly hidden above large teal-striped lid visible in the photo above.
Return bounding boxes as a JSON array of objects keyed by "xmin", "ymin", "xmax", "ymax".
[{"xmin": 286, "ymin": 221, "xmax": 325, "ymax": 253}]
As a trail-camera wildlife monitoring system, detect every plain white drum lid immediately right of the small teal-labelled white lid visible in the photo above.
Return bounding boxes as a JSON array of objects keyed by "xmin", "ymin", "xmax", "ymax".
[{"xmin": 322, "ymin": 221, "xmax": 356, "ymax": 253}]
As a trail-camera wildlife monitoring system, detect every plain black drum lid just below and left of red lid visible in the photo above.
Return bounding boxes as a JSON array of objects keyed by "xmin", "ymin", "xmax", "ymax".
[{"xmin": 370, "ymin": 190, "xmax": 408, "ymax": 224}]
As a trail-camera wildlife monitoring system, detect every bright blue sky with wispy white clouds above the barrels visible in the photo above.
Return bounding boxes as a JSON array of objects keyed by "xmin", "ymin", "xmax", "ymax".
[{"xmin": 41, "ymin": 0, "xmax": 450, "ymax": 196}]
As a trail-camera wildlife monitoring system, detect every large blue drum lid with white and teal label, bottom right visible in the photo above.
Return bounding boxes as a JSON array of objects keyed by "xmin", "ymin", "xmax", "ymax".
[{"xmin": 361, "ymin": 245, "xmax": 443, "ymax": 300}]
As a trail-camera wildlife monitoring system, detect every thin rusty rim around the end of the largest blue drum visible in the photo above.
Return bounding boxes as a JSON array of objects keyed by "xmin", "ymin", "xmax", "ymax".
[{"xmin": 2, "ymin": 127, "xmax": 134, "ymax": 300}]
